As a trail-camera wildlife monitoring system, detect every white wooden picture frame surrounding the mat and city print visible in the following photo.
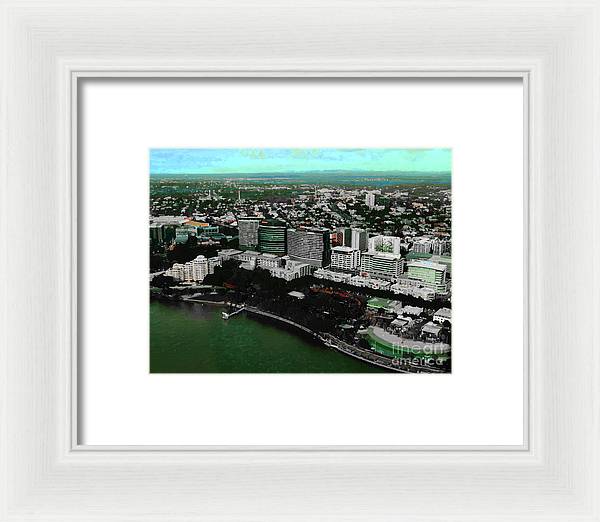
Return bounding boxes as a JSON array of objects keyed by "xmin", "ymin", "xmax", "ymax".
[{"xmin": 0, "ymin": 0, "xmax": 600, "ymax": 521}]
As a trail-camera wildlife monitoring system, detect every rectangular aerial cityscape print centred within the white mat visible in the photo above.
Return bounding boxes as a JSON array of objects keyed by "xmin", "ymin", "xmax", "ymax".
[{"xmin": 149, "ymin": 148, "xmax": 452, "ymax": 373}]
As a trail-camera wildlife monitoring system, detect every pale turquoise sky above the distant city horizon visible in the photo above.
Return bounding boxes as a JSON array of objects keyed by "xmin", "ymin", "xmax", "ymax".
[{"xmin": 150, "ymin": 148, "xmax": 451, "ymax": 175}]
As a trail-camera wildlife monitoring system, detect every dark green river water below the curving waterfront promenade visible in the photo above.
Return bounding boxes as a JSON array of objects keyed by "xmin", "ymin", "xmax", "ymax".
[{"xmin": 150, "ymin": 301, "xmax": 386, "ymax": 373}]
